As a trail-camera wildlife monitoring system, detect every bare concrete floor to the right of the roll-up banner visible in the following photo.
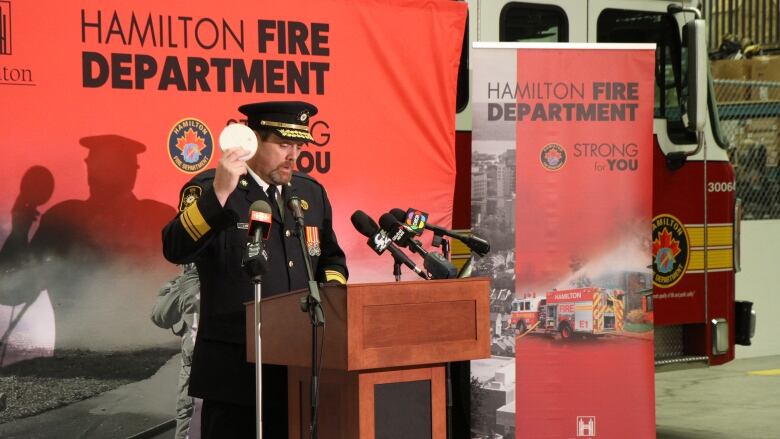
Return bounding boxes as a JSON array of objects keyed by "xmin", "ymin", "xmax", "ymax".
[{"xmin": 655, "ymin": 355, "xmax": 780, "ymax": 439}]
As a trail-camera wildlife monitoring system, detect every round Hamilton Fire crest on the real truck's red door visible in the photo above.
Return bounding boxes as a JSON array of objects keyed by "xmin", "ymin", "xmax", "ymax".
[{"xmin": 653, "ymin": 214, "xmax": 690, "ymax": 288}]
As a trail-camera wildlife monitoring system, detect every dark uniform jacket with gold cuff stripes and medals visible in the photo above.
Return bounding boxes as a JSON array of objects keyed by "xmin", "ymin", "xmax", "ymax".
[{"xmin": 163, "ymin": 170, "xmax": 348, "ymax": 404}]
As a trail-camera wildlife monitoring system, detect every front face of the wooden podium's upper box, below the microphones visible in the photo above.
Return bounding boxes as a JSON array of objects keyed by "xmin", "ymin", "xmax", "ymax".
[{"xmin": 347, "ymin": 278, "xmax": 490, "ymax": 370}]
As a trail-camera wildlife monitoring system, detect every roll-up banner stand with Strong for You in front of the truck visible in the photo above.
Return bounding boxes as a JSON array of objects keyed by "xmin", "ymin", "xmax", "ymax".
[{"xmin": 471, "ymin": 43, "xmax": 655, "ymax": 439}]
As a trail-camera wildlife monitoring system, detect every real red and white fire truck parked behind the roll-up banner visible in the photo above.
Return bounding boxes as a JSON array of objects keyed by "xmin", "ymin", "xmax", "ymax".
[{"xmin": 453, "ymin": 0, "xmax": 755, "ymax": 368}]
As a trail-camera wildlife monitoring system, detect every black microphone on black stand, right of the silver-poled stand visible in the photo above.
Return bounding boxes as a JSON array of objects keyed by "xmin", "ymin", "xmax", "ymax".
[{"xmin": 289, "ymin": 195, "xmax": 325, "ymax": 439}]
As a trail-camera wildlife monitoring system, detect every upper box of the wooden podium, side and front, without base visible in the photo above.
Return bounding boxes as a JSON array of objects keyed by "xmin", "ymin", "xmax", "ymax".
[{"xmin": 246, "ymin": 278, "xmax": 490, "ymax": 371}]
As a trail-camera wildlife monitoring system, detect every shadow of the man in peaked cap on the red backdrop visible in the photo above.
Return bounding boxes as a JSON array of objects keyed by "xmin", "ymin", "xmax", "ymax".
[{"xmin": 0, "ymin": 134, "xmax": 175, "ymax": 364}]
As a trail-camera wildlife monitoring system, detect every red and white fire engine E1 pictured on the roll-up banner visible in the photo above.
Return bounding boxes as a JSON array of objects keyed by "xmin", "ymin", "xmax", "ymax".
[{"xmin": 511, "ymin": 287, "xmax": 625, "ymax": 340}]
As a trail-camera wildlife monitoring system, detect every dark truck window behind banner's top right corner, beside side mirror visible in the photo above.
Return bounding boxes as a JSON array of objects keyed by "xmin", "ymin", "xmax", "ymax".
[{"xmin": 596, "ymin": 9, "xmax": 696, "ymax": 143}]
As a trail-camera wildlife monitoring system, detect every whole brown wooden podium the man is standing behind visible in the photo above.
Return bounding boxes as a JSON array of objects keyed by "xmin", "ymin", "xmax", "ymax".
[{"xmin": 246, "ymin": 278, "xmax": 490, "ymax": 439}]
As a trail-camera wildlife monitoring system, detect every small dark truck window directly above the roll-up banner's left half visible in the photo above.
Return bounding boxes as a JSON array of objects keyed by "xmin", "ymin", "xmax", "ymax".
[{"xmin": 498, "ymin": 3, "xmax": 569, "ymax": 43}]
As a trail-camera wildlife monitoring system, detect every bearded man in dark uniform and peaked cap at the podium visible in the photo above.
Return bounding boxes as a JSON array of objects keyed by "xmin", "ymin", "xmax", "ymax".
[{"xmin": 163, "ymin": 102, "xmax": 348, "ymax": 438}]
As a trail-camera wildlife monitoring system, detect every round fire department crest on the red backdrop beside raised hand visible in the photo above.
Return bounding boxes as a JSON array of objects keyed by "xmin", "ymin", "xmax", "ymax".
[{"xmin": 168, "ymin": 118, "xmax": 214, "ymax": 174}]
